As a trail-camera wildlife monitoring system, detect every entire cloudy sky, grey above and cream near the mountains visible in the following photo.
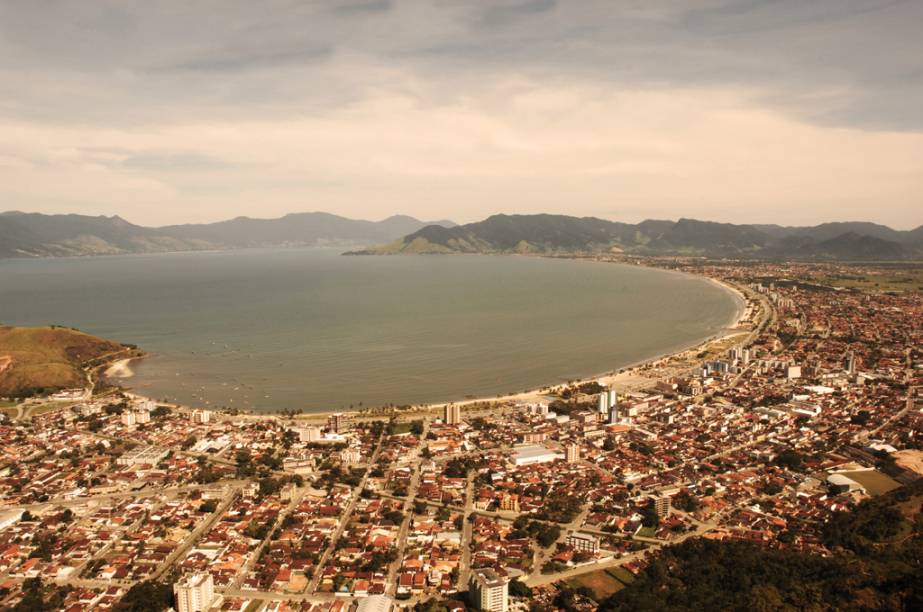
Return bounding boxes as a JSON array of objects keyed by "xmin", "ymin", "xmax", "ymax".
[{"xmin": 0, "ymin": 0, "xmax": 923, "ymax": 229}]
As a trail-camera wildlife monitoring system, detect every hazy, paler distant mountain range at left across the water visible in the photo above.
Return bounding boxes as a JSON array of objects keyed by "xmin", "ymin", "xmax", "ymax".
[{"xmin": 0, "ymin": 211, "xmax": 454, "ymax": 257}]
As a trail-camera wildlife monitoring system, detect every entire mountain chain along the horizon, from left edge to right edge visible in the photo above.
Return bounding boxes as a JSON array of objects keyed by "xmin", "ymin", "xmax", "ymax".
[{"xmin": 0, "ymin": 212, "xmax": 923, "ymax": 261}]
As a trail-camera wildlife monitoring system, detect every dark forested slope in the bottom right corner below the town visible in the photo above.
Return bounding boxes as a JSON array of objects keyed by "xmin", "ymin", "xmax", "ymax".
[{"xmin": 600, "ymin": 481, "xmax": 923, "ymax": 612}]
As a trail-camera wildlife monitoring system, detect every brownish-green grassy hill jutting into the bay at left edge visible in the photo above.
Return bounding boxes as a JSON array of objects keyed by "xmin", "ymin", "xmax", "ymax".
[{"xmin": 0, "ymin": 326, "xmax": 136, "ymax": 398}]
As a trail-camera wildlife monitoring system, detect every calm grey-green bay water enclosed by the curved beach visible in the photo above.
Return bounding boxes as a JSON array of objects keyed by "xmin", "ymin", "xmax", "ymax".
[{"xmin": 0, "ymin": 249, "xmax": 740, "ymax": 412}]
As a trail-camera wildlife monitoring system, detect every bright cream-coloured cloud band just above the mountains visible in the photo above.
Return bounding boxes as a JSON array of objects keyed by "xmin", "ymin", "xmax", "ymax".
[{"xmin": 0, "ymin": 79, "xmax": 923, "ymax": 227}]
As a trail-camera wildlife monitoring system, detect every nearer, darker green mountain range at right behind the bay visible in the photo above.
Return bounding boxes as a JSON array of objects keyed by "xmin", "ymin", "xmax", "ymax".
[{"xmin": 354, "ymin": 214, "xmax": 923, "ymax": 261}]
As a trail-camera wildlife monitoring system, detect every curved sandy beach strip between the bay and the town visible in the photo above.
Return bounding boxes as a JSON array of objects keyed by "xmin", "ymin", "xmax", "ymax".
[{"xmin": 113, "ymin": 261, "xmax": 751, "ymax": 422}]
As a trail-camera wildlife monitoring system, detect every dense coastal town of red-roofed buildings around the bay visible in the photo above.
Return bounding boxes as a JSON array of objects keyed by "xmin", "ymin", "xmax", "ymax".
[{"xmin": 0, "ymin": 256, "xmax": 923, "ymax": 612}]
